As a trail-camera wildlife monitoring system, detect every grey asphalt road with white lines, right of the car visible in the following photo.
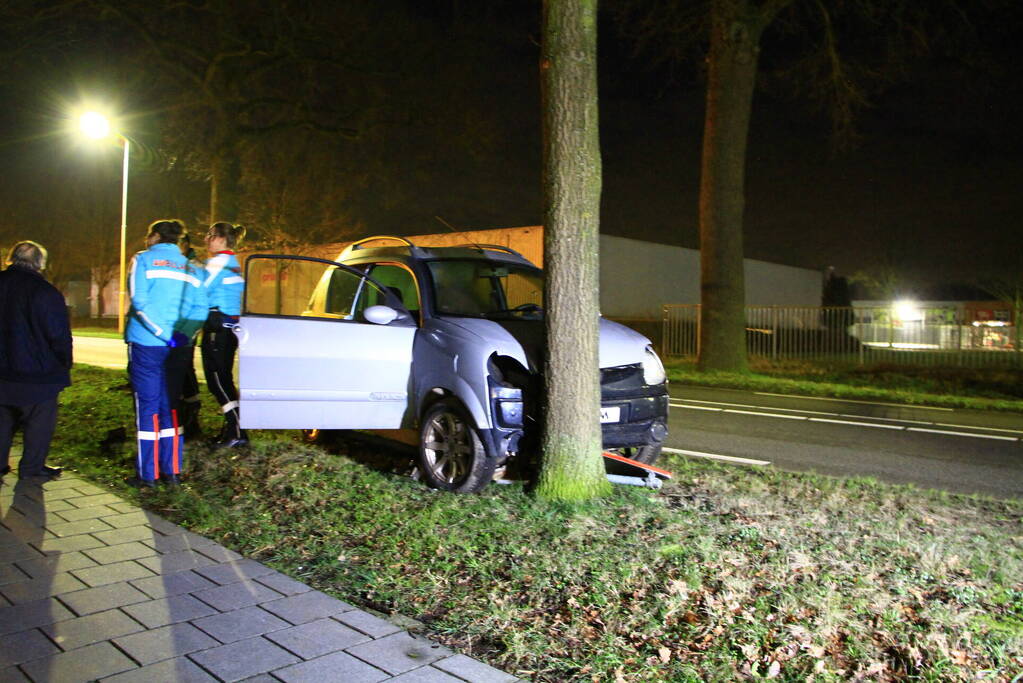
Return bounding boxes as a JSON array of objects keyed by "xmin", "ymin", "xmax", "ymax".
[{"xmin": 667, "ymin": 386, "xmax": 1023, "ymax": 498}]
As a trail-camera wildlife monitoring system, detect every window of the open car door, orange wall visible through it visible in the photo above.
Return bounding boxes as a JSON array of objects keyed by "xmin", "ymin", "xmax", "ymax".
[{"xmin": 244, "ymin": 256, "xmax": 385, "ymax": 319}]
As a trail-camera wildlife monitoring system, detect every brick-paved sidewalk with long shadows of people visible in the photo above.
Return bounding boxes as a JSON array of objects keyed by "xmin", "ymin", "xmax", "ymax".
[{"xmin": 0, "ymin": 458, "xmax": 517, "ymax": 683}]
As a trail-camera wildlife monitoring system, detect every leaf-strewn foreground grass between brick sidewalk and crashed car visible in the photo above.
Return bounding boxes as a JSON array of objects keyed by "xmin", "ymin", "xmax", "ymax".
[{"xmin": 53, "ymin": 366, "xmax": 1023, "ymax": 681}]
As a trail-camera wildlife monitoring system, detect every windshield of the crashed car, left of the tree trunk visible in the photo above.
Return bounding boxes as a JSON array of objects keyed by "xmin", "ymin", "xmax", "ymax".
[{"xmin": 429, "ymin": 260, "xmax": 543, "ymax": 319}]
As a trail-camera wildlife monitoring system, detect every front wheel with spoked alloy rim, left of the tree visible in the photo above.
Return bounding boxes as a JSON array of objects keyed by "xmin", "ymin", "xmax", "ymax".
[{"xmin": 418, "ymin": 399, "xmax": 497, "ymax": 493}]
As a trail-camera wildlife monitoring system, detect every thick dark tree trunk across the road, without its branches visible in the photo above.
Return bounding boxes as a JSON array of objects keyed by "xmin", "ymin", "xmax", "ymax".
[{"xmin": 699, "ymin": 0, "xmax": 761, "ymax": 371}]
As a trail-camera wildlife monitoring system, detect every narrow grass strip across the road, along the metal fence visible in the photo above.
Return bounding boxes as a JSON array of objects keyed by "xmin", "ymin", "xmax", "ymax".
[{"xmin": 665, "ymin": 360, "xmax": 1023, "ymax": 412}]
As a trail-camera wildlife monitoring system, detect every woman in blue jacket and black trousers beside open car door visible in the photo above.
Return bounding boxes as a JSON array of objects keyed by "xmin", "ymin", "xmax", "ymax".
[{"xmin": 203, "ymin": 222, "xmax": 249, "ymax": 448}]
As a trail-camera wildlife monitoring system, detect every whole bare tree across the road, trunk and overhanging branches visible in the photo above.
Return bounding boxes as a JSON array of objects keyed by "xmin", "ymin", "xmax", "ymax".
[{"xmin": 616, "ymin": 0, "xmax": 998, "ymax": 371}]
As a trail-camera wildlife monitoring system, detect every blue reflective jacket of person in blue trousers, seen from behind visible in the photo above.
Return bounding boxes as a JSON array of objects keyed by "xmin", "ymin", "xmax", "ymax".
[{"xmin": 125, "ymin": 242, "xmax": 209, "ymax": 347}]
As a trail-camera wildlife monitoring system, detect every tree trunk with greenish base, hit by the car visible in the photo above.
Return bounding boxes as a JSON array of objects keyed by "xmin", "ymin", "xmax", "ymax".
[{"xmin": 537, "ymin": 0, "xmax": 610, "ymax": 500}]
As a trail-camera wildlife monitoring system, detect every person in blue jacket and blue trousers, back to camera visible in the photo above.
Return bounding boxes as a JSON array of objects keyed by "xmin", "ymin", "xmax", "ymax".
[{"xmin": 125, "ymin": 220, "xmax": 206, "ymax": 487}]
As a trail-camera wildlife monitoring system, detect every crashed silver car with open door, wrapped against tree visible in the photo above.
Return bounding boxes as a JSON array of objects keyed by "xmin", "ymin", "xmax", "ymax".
[{"xmin": 235, "ymin": 236, "xmax": 668, "ymax": 493}]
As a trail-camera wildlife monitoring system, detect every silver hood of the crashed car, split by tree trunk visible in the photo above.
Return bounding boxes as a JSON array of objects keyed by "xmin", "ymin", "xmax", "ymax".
[{"xmin": 444, "ymin": 317, "xmax": 651, "ymax": 372}]
